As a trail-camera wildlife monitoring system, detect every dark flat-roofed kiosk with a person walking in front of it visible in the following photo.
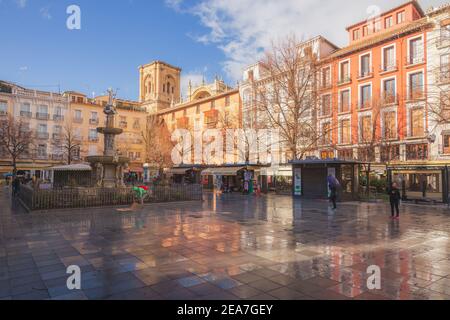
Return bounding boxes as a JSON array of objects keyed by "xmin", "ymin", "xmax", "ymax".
[{"xmin": 291, "ymin": 160, "xmax": 362, "ymax": 201}]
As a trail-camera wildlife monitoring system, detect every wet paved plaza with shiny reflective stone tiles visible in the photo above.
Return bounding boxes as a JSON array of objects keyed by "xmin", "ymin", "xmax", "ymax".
[{"xmin": 0, "ymin": 189, "xmax": 450, "ymax": 300}]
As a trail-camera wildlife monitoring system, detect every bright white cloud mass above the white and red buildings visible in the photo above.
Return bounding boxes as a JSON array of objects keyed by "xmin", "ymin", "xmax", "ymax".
[{"xmin": 166, "ymin": 0, "xmax": 442, "ymax": 80}]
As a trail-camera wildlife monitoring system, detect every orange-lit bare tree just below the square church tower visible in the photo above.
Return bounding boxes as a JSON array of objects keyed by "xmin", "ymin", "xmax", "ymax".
[{"xmin": 142, "ymin": 115, "xmax": 174, "ymax": 175}]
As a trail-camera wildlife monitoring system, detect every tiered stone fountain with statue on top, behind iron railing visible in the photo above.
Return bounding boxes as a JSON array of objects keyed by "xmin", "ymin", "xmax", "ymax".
[{"xmin": 86, "ymin": 89, "xmax": 130, "ymax": 188}]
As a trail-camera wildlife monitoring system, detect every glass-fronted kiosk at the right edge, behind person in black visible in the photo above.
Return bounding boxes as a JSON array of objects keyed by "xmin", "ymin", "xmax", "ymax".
[{"xmin": 387, "ymin": 162, "xmax": 449, "ymax": 203}]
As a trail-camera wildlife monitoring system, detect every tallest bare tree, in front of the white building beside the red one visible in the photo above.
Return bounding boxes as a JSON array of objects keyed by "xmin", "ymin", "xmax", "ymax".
[{"xmin": 253, "ymin": 36, "xmax": 321, "ymax": 160}]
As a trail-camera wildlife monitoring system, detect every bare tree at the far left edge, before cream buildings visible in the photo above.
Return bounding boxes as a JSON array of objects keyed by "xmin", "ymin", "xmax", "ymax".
[{"xmin": 0, "ymin": 116, "xmax": 35, "ymax": 176}]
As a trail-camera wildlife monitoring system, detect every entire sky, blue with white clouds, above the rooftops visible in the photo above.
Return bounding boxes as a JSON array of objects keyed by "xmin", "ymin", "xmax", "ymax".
[{"xmin": 0, "ymin": 0, "xmax": 444, "ymax": 99}]
